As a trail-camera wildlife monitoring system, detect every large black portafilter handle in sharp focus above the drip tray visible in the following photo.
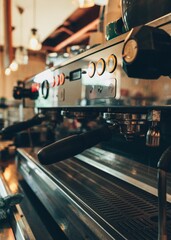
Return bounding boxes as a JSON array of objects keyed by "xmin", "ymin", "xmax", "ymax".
[{"xmin": 38, "ymin": 126, "xmax": 112, "ymax": 165}]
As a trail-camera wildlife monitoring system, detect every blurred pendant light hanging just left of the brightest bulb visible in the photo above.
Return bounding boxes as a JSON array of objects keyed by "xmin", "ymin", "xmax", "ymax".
[{"xmin": 15, "ymin": 6, "xmax": 28, "ymax": 65}]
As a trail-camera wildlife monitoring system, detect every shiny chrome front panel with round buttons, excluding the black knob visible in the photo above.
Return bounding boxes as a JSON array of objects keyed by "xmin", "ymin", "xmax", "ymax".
[{"xmin": 26, "ymin": 14, "xmax": 171, "ymax": 108}]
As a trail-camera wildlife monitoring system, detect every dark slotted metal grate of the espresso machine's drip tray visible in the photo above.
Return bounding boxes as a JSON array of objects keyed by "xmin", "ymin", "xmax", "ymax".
[{"xmin": 46, "ymin": 159, "xmax": 171, "ymax": 240}]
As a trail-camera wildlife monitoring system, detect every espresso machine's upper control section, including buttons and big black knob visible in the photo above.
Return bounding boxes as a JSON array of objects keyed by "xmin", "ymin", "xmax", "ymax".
[{"xmin": 22, "ymin": 14, "xmax": 171, "ymax": 108}]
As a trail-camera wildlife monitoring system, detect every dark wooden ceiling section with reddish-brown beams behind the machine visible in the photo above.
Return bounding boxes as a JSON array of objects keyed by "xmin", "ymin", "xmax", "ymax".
[{"xmin": 42, "ymin": 5, "xmax": 100, "ymax": 52}]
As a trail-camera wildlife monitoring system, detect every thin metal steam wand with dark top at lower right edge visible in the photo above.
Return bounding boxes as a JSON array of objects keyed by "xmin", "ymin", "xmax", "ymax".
[{"xmin": 157, "ymin": 146, "xmax": 171, "ymax": 240}]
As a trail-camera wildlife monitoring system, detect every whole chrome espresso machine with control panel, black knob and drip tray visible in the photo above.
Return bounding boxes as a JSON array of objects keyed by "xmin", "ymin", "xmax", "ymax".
[{"xmin": 1, "ymin": 14, "xmax": 171, "ymax": 240}]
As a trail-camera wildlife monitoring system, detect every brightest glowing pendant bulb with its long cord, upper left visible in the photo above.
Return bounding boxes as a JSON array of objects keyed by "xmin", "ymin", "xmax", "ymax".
[{"xmin": 28, "ymin": 0, "xmax": 42, "ymax": 51}]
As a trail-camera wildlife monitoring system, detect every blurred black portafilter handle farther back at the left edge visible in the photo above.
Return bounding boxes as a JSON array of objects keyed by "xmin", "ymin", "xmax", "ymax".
[{"xmin": 0, "ymin": 116, "xmax": 44, "ymax": 136}]
